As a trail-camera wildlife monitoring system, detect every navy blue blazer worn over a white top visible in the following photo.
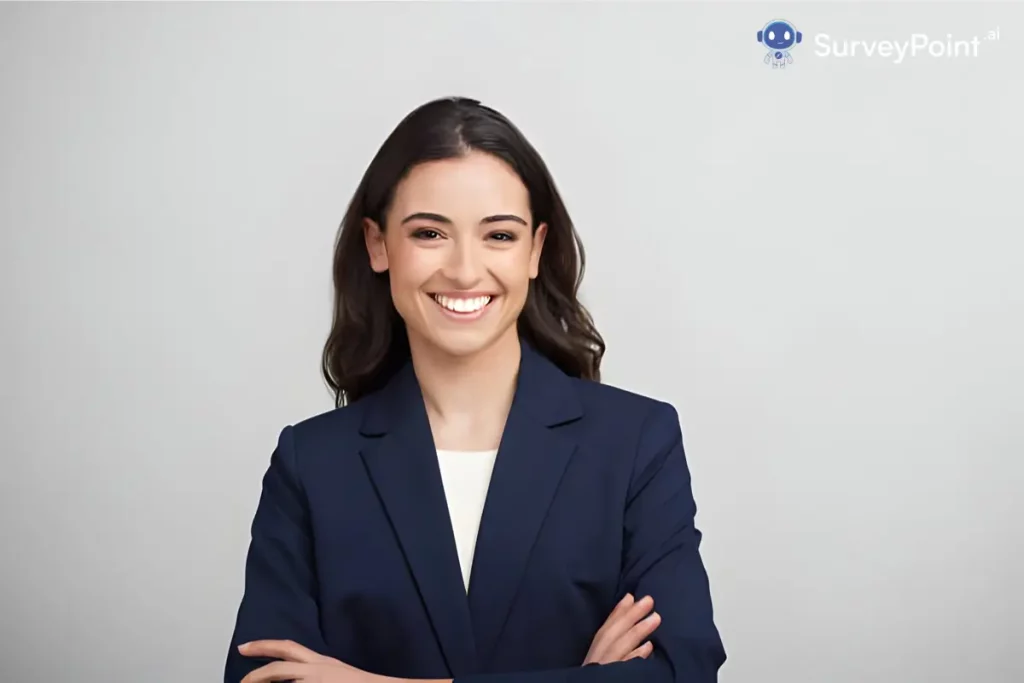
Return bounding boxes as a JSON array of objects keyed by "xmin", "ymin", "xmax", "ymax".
[{"xmin": 224, "ymin": 344, "xmax": 725, "ymax": 683}]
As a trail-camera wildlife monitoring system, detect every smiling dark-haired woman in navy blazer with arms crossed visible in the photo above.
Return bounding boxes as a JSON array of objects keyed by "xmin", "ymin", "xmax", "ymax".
[{"xmin": 224, "ymin": 98, "xmax": 725, "ymax": 683}]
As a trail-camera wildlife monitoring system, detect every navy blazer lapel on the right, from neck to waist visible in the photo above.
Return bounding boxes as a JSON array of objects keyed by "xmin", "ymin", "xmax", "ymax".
[{"xmin": 469, "ymin": 343, "xmax": 583, "ymax": 668}]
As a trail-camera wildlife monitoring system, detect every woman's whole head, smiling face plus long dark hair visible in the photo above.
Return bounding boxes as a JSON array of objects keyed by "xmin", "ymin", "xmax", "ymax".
[{"xmin": 324, "ymin": 98, "xmax": 604, "ymax": 405}]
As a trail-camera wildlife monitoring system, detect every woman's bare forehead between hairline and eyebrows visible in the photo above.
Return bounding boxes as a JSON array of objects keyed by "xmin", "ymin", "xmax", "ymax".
[{"xmin": 394, "ymin": 152, "xmax": 529, "ymax": 213}]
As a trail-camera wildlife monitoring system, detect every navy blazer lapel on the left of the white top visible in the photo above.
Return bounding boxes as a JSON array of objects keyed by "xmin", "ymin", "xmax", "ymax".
[{"xmin": 361, "ymin": 364, "xmax": 476, "ymax": 677}]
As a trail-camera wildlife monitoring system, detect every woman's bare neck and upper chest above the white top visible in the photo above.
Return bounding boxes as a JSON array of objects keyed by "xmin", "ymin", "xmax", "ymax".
[{"xmin": 410, "ymin": 328, "xmax": 522, "ymax": 450}]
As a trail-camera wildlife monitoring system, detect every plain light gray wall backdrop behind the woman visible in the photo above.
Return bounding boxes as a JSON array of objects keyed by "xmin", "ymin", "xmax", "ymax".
[{"xmin": 0, "ymin": 2, "xmax": 1024, "ymax": 683}]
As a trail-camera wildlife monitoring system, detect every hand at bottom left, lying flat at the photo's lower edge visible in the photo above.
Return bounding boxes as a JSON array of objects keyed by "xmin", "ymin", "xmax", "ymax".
[{"xmin": 239, "ymin": 640, "xmax": 390, "ymax": 683}]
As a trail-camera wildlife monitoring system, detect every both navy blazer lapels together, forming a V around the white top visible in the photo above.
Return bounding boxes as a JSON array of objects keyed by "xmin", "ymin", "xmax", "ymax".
[{"xmin": 360, "ymin": 342, "xmax": 583, "ymax": 677}]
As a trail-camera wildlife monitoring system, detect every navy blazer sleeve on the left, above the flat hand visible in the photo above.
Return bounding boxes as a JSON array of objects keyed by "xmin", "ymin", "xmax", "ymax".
[{"xmin": 224, "ymin": 427, "xmax": 327, "ymax": 683}]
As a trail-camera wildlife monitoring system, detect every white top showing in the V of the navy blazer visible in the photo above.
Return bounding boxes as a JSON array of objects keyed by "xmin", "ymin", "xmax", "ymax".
[{"xmin": 437, "ymin": 451, "xmax": 498, "ymax": 592}]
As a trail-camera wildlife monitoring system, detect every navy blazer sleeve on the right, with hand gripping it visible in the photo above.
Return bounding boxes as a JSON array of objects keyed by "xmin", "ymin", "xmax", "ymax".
[{"xmin": 455, "ymin": 402, "xmax": 726, "ymax": 683}]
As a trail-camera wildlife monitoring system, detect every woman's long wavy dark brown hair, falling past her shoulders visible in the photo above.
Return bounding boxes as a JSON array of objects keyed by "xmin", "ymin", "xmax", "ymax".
[{"xmin": 322, "ymin": 97, "xmax": 605, "ymax": 407}]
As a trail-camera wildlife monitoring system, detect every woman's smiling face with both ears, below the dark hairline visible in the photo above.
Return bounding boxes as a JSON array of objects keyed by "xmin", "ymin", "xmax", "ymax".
[{"xmin": 364, "ymin": 153, "xmax": 547, "ymax": 356}]
